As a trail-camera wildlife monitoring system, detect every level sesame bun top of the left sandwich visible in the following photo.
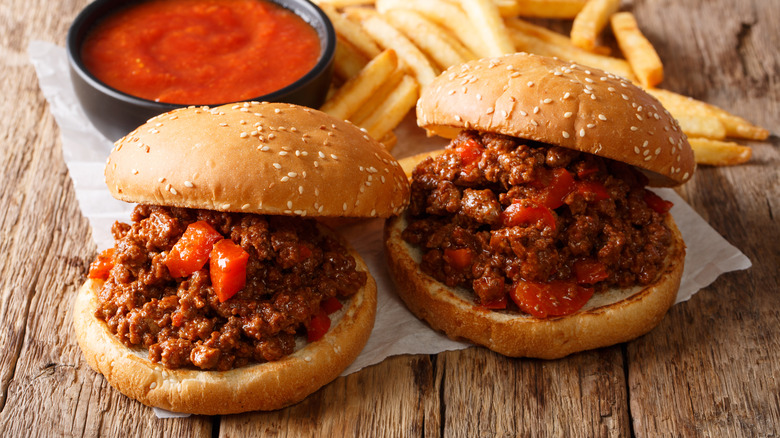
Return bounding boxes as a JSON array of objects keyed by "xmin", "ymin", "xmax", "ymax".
[{"xmin": 105, "ymin": 102, "xmax": 409, "ymax": 217}]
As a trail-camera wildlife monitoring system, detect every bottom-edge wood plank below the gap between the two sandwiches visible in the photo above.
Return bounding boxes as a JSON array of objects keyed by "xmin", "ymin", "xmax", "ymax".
[{"xmin": 219, "ymin": 356, "xmax": 440, "ymax": 438}]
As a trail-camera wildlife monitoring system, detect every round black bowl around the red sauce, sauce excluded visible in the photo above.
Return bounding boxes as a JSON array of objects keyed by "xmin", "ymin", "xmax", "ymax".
[{"xmin": 67, "ymin": 0, "xmax": 336, "ymax": 141}]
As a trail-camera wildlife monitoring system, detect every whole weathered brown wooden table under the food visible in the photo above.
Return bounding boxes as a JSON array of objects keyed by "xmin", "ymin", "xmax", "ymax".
[{"xmin": 0, "ymin": 0, "xmax": 780, "ymax": 437}]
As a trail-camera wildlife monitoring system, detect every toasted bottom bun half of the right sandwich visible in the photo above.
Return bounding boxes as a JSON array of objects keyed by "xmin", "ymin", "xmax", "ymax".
[{"xmin": 385, "ymin": 215, "xmax": 685, "ymax": 359}]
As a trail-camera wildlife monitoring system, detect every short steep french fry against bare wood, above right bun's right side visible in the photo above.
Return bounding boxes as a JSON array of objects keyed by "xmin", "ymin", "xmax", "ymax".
[{"xmin": 610, "ymin": 12, "xmax": 664, "ymax": 87}]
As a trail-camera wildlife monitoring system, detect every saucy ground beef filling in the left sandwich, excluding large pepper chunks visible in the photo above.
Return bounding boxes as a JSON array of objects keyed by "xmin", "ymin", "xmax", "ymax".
[{"xmin": 95, "ymin": 205, "xmax": 366, "ymax": 370}]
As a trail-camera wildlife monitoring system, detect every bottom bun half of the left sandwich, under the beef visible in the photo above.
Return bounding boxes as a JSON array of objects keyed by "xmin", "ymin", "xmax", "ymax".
[{"xmin": 74, "ymin": 236, "xmax": 376, "ymax": 415}]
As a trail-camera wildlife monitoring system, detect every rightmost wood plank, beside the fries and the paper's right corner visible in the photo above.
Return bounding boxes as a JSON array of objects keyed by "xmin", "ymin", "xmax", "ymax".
[{"xmin": 627, "ymin": 0, "xmax": 780, "ymax": 437}]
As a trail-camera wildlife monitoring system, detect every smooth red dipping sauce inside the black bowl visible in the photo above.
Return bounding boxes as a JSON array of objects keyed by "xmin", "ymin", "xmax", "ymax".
[{"xmin": 81, "ymin": 0, "xmax": 320, "ymax": 105}]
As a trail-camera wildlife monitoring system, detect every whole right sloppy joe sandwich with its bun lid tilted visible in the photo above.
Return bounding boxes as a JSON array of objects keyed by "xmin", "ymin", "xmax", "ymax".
[{"xmin": 385, "ymin": 53, "xmax": 695, "ymax": 358}]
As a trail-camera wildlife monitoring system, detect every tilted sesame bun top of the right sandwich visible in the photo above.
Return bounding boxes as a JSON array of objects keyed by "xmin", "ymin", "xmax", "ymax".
[{"xmin": 417, "ymin": 53, "xmax": 696, "ymax": 186}]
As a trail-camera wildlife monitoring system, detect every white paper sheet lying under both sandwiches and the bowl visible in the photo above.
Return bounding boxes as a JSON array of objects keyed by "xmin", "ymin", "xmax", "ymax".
[{"xmin": 28, "ymin": 41, "xmax": 751, "ymax": 417}]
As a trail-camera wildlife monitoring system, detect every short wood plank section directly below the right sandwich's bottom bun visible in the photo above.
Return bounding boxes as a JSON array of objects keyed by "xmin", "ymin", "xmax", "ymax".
[{"xmin": 437, "ymin": 347, "xmax": 629, "ymax": 437}]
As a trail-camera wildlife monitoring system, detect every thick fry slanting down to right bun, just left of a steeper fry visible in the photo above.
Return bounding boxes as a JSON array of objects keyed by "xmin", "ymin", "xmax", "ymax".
[{"xmin": 383, "ymin": 9, "xmax": 475, "ymax": 70}]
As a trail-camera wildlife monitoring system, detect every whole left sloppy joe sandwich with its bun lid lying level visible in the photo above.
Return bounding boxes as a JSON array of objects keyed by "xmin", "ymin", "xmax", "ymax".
[{"xmin": 74, "ymin": 102, "xmax": 409, "ymax": 415}]
